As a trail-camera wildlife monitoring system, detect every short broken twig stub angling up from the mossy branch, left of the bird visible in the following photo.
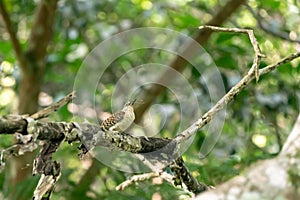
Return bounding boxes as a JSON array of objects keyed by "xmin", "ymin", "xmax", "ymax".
[{"xmin": 30, "ymin": 91, "xmax": 75, "ymax": 120}]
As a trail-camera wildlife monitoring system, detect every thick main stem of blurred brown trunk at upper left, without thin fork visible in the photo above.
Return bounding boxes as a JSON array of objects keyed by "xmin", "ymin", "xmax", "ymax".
[{"xmin": 18, "ymin": 0, "xmax": 58, "ymax": 114}]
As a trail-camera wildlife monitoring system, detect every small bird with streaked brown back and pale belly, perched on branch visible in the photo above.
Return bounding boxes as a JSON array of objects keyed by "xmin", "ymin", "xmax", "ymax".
[{"xmin": 100, "ymin": 99, "xmax": 136, "ymax": 132}]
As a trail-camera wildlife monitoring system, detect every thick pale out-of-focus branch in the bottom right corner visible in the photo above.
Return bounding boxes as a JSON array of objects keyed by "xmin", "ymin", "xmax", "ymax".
[{"xmin": 196, "ymin": 115, "xmax": 300, "ymax": 200}]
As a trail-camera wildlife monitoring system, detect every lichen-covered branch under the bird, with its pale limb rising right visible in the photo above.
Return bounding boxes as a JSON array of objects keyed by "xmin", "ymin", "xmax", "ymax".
[{"xmin": 0, "ymin": 38, "xmax": 300, "ymax": 198}]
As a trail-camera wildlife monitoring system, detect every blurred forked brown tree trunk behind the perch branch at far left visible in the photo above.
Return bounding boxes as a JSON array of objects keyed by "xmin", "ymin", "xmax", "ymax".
[{"xmin": 0, "ymin": 0, "xmax": 58, "ymax": 195}]
